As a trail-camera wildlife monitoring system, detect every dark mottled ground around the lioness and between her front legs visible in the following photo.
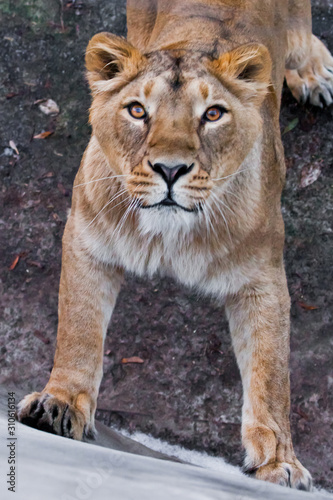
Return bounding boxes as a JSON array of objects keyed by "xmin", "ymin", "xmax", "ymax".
[{"xmin": 0, "ymin": 0, "xmax": 333, "ymax": 489}]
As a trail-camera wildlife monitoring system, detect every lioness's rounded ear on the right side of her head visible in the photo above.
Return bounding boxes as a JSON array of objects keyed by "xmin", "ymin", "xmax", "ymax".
[{"xmin": 210, "ymin": 43, "xmax": 272, "ymax": 104}]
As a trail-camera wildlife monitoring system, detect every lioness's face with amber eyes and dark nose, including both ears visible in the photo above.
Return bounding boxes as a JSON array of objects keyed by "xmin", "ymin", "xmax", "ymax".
[{"xmin": 87, "ymin": 35, "xmax": 270, "ymax": 221}]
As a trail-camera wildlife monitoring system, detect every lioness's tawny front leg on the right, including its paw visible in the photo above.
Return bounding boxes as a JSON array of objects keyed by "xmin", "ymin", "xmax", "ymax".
[{"xmin": 226, "ymin": 269, "xmax": 311, "ymax": 490}]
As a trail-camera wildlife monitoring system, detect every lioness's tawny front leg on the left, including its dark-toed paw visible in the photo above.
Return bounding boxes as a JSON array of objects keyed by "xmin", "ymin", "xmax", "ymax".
[{"xmin": 18, "ymin": 219, "xmax": 122, "ymax": 439}]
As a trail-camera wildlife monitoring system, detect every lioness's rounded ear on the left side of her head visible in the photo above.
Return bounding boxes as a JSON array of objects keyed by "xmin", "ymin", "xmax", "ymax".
[{"xmin": 86, "ymin": 33, "xmax": 145, "ymax": 92}]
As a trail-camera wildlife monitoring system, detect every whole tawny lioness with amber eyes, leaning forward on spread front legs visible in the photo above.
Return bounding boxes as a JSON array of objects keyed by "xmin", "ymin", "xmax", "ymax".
[{"xmin": 18, "ymin": 0, "xmax": 333, "ymax": 490}]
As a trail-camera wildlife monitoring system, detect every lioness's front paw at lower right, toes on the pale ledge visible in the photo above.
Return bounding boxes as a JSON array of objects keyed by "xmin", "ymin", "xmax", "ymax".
[{"xmin": 254, "ymin": 460, "xmax": 312, "ymax": 491}]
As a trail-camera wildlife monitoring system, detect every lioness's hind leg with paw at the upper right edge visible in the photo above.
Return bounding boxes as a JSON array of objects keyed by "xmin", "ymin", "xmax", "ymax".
[{"xmin": 285, "ymin": 0, "xmax": 333, "ymax": 107}]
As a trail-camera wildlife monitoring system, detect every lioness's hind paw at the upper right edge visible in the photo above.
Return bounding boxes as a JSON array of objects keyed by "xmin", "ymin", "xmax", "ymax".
[{"xmin": 285, "ymin": 35, "xmax": 333, "ymax": 108}]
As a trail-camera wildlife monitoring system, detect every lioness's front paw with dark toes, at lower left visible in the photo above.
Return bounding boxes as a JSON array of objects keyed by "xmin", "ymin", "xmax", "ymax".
[{"xmin": 17, "ymin": 392, "xmax": 91, "ymax": 440}]
